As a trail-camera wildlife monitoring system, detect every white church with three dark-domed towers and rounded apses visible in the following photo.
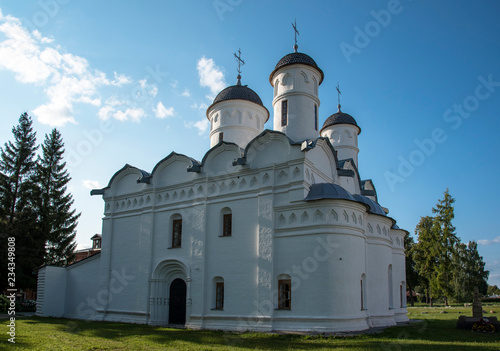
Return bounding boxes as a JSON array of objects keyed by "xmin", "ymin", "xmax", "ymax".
[{"xmin": 37, "ymin": 46, "xmax": 408, "ymax": 332}]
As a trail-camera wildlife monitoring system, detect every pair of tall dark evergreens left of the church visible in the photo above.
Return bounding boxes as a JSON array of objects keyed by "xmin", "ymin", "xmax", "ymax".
[{"xmin": 0, "ymin": 113, "xmax": 80, "ymax": 293}]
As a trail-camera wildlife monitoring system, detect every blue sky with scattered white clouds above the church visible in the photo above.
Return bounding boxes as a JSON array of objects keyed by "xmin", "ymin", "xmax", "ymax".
[{"xmin": 0, "ymin": 0, "xmax": 500, "ymax": 285}]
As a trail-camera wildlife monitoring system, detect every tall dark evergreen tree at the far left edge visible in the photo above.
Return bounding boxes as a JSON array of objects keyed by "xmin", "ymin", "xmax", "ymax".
[{"xmin": 0, "ymin": 113, "xmax": 44, "ymax": 289}]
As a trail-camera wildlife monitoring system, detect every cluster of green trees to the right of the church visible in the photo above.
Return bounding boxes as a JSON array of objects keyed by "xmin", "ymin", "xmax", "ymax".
[{"xmin": 405, "ymin": 189, "xmax": 489, "ymax": 306}]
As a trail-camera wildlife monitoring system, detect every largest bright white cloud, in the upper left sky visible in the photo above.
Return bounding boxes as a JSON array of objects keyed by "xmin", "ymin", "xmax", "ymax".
[{"xmin": 0, "ymin": 12, "xmax": 141, "ymax": 127}]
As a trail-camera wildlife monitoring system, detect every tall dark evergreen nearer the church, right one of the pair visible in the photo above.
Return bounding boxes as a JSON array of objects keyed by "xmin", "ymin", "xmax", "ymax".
[{"xmin": 36, "ymin": 129, "xmax": 80, "ymax": 265}]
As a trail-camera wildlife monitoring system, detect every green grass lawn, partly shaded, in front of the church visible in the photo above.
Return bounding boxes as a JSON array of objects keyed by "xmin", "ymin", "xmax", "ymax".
[{"xmin": 0, "ymin": 305, "xmax": 500, "ymax": 351}]
